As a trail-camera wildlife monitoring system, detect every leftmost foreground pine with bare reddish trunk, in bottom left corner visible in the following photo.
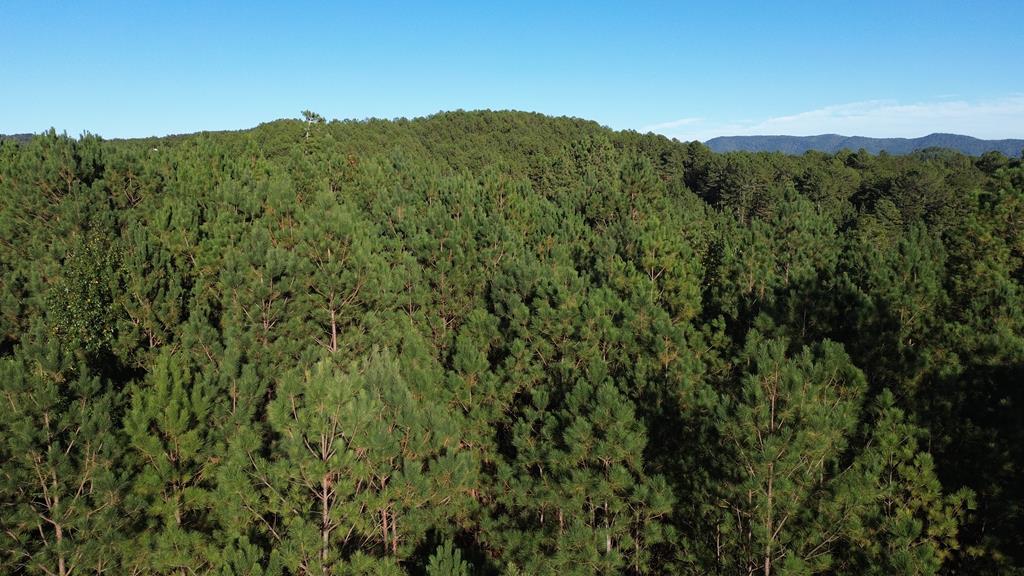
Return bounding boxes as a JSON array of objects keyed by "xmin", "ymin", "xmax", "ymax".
[{"xmin": 0, "ymin": 334, "xmax": 125, "ymax": 576}]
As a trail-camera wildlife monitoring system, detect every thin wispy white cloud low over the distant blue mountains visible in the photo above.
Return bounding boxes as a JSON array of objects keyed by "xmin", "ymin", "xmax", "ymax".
[{"xmin": 643, "ymin": 94, "xmax": 1024, "ymax": 140}]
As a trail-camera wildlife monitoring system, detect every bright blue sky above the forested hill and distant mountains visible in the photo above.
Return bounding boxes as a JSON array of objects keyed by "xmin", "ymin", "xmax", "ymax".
[{"xmin": 0, "ymin": 0, "xmax": 1024, "ymax": 139}]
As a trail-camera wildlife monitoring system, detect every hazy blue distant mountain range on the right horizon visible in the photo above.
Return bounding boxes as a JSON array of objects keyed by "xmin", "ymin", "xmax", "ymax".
[{"xmin": 705, "ymin": 134, "xmax": 1024, "ymax": 158}]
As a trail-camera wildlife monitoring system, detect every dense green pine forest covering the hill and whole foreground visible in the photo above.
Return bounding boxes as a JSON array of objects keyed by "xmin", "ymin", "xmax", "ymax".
[{"xmin": 0, "ymin": 112, "xmax": 1024, "ymax": 576}]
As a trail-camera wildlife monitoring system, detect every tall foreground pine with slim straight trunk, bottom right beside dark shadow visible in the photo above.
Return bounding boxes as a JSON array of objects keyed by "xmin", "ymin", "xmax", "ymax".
[{"xmin": 709, "ymin": 332, "xmax": 866, "ymax": 576}]
